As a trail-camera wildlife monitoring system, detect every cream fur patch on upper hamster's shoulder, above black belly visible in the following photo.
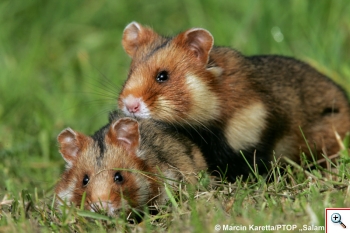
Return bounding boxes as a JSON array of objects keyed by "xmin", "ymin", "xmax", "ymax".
[{"xmin": 225, "ymin": 102, "xmax": 268, "ymax": 151}]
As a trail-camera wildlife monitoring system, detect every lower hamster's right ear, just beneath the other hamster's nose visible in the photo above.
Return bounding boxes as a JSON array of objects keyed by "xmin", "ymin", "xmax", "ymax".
[{"xmin": 107, "ymin": 117, "xmax": 140, "ymax": 152}]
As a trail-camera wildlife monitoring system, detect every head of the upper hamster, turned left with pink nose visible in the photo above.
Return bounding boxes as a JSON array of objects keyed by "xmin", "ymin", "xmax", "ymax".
[{"xmin": 118, "ymin": 22, "xmax": 221, "ymax": 124}]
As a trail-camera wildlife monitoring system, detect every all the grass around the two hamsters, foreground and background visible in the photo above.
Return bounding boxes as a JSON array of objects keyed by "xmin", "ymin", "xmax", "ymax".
[{"xmin": 0, "ymin": 0, "xmax": 350, "ymax": 232}]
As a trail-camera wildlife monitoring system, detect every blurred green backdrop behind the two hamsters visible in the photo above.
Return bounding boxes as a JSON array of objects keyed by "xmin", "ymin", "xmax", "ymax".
[{"xmin": 0, "ymin": 0, "xmax": 350, "ymax": 199}]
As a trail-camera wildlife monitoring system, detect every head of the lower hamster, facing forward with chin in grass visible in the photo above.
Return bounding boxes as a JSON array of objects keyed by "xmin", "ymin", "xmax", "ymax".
[{"xmin": 55, "ymin": 118, "xmax": 157, "ymax": 215}]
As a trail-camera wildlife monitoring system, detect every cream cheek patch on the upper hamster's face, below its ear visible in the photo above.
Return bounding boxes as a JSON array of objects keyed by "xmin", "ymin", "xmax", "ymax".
[{"xmin": 186, "ymin": 75, "xmax": 220, "ymax": 124}]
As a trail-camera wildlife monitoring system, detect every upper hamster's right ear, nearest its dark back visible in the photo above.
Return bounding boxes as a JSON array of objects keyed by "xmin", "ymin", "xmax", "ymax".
[{"xmin": 175, "ymin": 28, "xmax": 214, "ymax": 65}]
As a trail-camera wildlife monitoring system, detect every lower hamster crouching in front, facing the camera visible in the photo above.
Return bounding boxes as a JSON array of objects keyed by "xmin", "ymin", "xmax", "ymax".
[{"xmin": 55, "ymin": 115, "xmax": 207, "ymax": 216}]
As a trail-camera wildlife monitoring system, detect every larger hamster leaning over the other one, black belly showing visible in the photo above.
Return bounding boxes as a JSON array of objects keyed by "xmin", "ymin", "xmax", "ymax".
[{"xmin": 118, "ymin": 22, "xmax": 350, "ymax": 181}]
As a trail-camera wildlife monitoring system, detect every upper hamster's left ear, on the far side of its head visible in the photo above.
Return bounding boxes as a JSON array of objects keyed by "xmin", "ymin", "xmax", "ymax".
[{"xmin": 122, "ymin": 22, "xmax": 158, "ymax": 58}]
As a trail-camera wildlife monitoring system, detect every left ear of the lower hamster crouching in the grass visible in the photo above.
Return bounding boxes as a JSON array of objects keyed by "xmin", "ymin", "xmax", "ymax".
[{"xmin": 57, "ymin": 128, "xmax": 85, "ymax": 165}]
